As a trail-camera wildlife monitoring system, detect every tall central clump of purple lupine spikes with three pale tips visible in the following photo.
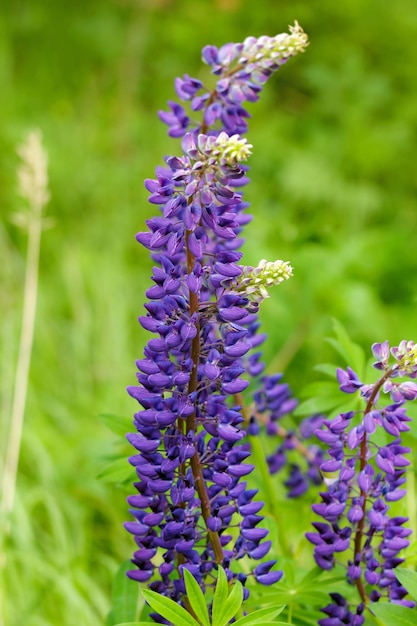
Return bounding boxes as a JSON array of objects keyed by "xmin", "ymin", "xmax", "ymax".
[{"xmin": 125, "ymin": 24, "xmax": 307, "ymax": 608}]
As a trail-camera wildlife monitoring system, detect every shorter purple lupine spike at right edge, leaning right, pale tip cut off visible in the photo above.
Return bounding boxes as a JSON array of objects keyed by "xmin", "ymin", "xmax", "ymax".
[{"xmin": 306, "ymin": 341, "xmax": 417, "ymax": 612}]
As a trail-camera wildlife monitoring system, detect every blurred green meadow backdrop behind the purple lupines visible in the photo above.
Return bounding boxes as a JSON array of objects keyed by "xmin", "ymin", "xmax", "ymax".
[{"xmin": 0, "ymin": 0, "xmax": 417, "ymax": 626}]
